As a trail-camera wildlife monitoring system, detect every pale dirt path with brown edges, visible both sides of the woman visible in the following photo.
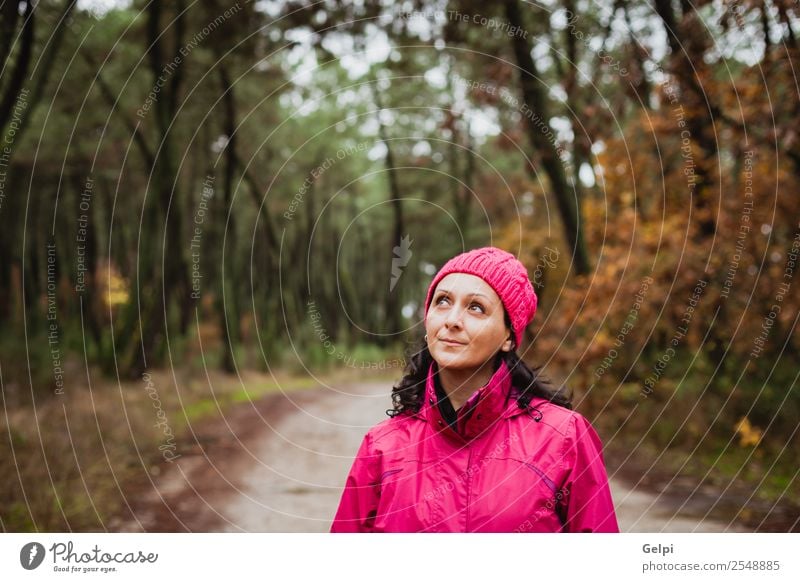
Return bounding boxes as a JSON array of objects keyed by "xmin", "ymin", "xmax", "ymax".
[{"xmin": 117, "ymin": 381, "xmax": 746, "ymax": 532}]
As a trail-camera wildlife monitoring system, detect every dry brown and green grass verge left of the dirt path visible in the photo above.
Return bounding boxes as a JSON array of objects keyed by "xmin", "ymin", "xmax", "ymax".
[{"xmin": 0, "ymin": 352, "xmax": 400, "ymax": 532}]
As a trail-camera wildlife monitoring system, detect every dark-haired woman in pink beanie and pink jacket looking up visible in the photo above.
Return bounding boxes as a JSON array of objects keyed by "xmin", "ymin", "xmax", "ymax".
[{"xmin": 331, "ymin": 247, "xmax": 619, "ymax": 532}]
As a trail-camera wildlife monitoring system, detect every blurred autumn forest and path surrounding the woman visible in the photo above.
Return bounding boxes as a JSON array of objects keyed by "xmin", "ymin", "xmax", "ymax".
[{"xmin": 0, "ymin": 0, "xmax": 800, "ymax": 531}]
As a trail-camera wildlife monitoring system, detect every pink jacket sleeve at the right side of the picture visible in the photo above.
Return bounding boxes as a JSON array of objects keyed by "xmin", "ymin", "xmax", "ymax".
[{"xmin": 560, "ymin": 414, "xmax": 619, "ymax": 533}]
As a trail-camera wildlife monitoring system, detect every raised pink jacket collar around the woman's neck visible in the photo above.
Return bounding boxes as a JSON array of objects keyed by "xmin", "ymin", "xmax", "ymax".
[{"xmin": 420, "ymin": 362, "xmax": 521, "ymax": 440}]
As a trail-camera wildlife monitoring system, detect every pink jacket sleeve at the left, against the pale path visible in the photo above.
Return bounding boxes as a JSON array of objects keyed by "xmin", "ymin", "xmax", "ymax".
[{"xmin": 331, "ymin": 433, "xmax": 380, "ymax": 533}]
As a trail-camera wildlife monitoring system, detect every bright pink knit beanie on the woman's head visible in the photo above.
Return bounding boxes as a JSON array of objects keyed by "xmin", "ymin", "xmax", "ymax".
[{"xmin": 425, "ymin": 247, "xmax": 538, "ymax": 346}]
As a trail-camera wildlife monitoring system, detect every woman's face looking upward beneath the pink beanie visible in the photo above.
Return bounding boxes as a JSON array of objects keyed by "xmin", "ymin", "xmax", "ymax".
[{"xmin": 425, "ymin": 273, "xmax": 511, "ymax": 370}]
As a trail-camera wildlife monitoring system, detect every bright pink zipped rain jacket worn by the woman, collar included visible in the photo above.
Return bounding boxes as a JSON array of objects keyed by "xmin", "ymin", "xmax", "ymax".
[{"xmin": 331, "ymin": 364, "xmax": 619, "ymax": 532}]
